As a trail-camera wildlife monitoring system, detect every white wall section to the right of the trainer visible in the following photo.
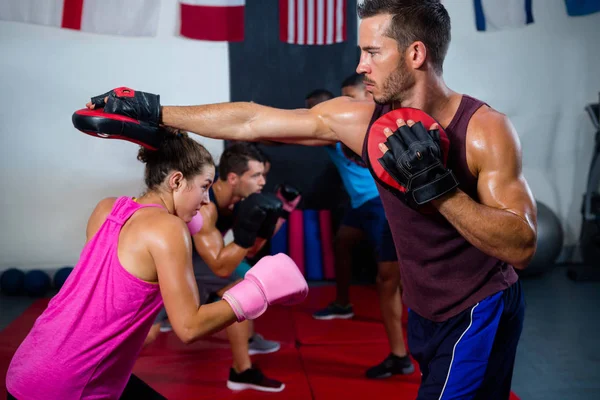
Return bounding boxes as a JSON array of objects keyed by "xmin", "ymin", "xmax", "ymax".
[{"xmin": 444, "ymin": 0, "xmax": 600, "ymax": 253}]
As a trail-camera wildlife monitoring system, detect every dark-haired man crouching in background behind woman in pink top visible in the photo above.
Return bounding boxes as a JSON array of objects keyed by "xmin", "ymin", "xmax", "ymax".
[{"xmin": 149, "ymin": 143, "xmax": 292, "ymax": 391}]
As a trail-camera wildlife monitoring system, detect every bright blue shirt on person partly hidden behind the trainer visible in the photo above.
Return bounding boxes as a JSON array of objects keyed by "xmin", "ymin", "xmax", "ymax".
[{"xmin": 326, "ymin": 142, "xmax": 379, "ymax": 208}]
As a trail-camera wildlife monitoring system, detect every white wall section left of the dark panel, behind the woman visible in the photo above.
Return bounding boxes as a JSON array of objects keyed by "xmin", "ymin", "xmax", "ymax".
[{"xmin": 0, "ymin": 1, "xmax": 229, "ymax": 270}]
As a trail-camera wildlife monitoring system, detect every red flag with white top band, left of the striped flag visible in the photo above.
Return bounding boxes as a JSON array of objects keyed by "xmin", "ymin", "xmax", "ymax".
[{"xmin": 179, "ymin": 0, "xmax": 245, "ymax": 42}]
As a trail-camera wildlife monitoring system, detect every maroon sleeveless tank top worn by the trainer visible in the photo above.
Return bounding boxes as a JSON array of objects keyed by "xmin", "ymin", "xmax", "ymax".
[{"xmin": 363, "ymin": 95, "xmax": 518, "ymax": 322}]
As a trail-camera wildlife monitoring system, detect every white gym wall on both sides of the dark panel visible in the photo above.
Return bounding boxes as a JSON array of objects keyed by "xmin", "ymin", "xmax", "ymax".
[{"xmin": 0, "ymin": 0, "xmax": 600, "ymax": 270}]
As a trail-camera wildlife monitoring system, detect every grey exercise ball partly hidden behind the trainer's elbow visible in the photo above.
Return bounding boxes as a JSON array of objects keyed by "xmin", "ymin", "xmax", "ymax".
[{"xmin": 519, "ymin": 201, "xmax": 564, "ymax": 277}]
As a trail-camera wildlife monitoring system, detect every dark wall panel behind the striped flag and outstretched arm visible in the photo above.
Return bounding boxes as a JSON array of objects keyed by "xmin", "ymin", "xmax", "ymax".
[{"xmin": 229, "ymin": 0, "xmax": 358, "ymax": 209}]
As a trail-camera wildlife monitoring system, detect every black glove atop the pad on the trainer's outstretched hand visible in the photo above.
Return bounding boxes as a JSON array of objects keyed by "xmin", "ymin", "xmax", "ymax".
[{"xmin": 92, "ymin": 87, "xmax": 162, "ymax": 126}]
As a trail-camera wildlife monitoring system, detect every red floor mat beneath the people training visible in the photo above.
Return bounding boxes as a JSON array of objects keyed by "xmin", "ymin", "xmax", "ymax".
[{"xmin": 0, "ymin": 286, "xmax": 518, "ymax": 400}]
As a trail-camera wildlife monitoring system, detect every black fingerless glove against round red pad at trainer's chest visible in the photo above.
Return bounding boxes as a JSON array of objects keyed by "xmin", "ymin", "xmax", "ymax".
[{"xmin": 378, "ymin": 122, "xmax": 458, "ymax": 208}]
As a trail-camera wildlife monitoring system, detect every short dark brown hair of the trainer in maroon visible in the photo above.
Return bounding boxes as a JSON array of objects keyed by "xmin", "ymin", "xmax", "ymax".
[{"xmin": 357, "ymin": 0, "xmax": 451, "ymax": 73}]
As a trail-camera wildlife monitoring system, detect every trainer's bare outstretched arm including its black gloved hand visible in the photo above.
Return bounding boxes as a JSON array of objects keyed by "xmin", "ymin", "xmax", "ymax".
[{"xmin": 87, "ymin": 87, "xmax": 375, "ymax": 154}]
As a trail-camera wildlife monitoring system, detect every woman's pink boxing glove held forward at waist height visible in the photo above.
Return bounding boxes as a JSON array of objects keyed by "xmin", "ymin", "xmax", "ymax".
[{"xmin": 223, "ymin": 253, "xmax": 308, "ymax": 322}]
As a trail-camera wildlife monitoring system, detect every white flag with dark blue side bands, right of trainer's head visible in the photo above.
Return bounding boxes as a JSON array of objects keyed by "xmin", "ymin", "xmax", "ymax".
[{"xmin": 475, "ymin": 0, "xmax": 533, "ymax": 31}]
